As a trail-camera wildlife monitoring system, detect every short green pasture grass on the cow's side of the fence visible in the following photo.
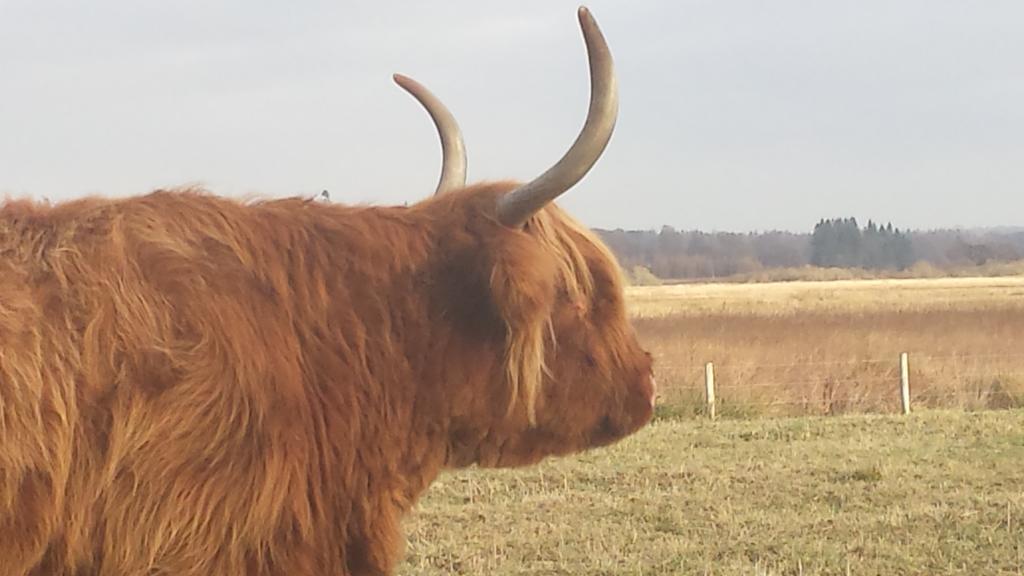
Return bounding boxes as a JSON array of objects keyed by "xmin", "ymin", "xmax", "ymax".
[{"xmin": 399, "ymin": 410, "xmax": 1024, "ymax": 575}]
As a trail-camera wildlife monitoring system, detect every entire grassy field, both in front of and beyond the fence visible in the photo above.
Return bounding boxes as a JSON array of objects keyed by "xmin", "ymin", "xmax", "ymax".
[{"xmin": 400, "ymin": 278, "xmax": 1024, "ymax": 575}]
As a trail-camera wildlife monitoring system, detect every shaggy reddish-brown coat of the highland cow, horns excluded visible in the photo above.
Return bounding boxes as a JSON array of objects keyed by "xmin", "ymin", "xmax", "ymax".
[{"xmin": 0, "ymin": 183, "xmax": 653, "ymax": 576}]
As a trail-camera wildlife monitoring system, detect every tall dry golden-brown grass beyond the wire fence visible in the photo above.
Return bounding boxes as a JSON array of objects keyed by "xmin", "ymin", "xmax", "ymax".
[{"xmin": 628, "ymin": 277, "xmax": 1024, "ymax": 415}]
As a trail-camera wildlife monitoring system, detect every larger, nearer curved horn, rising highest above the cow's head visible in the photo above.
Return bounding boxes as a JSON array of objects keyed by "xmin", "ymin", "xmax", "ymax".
[{"xmin": 498, "ymin": 6, "xmax": 618, "ymax": 228}]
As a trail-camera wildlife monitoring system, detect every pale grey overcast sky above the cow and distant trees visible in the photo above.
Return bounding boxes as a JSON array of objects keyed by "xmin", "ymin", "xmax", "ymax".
[{"xmin": 0, "ymin": 0, "xmax": 1024, "ymax": 232}]
